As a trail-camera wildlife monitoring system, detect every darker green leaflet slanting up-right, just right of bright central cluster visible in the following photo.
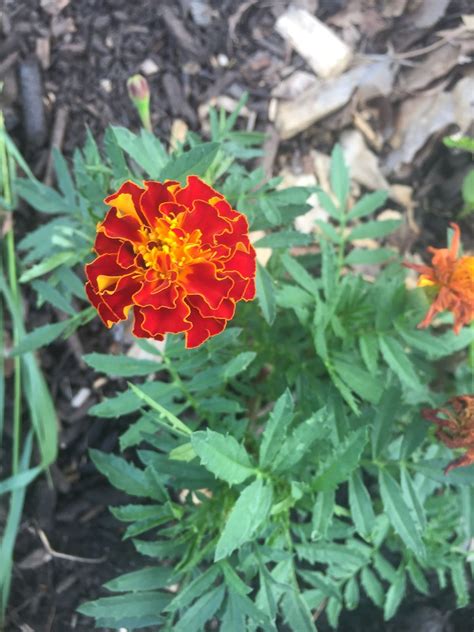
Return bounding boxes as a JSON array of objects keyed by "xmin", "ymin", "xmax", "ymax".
[{"xmin": 311, "ymin": 428, "xmax": 367, "ymax": 491}]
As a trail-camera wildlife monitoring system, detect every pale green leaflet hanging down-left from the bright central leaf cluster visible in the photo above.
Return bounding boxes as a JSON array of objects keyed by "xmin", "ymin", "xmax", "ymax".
[{"xmin": 214, "ymin": 479, "xmax": 273, "ymax": 562}]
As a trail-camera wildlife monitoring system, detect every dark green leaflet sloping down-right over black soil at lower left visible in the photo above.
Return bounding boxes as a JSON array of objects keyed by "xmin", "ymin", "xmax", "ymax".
[{"xmin": 89, "ymin": 448, "xmax": 161, "ymax": 498}]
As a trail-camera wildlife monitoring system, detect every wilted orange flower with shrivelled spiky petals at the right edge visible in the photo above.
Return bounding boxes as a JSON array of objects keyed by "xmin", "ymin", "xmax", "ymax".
[{"xmin": 404, "ymin": 223, "xmax": 474, "ymax": 334}]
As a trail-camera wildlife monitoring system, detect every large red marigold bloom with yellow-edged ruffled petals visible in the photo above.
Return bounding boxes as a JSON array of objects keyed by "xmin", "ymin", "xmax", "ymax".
[{"xmin": 86, "ymin": 176, "xmax": 256, "ymax": 348}]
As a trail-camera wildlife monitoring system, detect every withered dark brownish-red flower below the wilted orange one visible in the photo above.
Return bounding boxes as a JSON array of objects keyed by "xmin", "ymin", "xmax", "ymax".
[{"xmin": 421, "ymin": 395, "xmax": 474, "ymax": 474}]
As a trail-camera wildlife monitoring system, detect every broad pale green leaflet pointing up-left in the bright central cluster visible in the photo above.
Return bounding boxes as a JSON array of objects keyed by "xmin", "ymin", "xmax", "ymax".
[{"xmin": 191, "ymin": 428, "xmax": 255, "ymax": 485}]
